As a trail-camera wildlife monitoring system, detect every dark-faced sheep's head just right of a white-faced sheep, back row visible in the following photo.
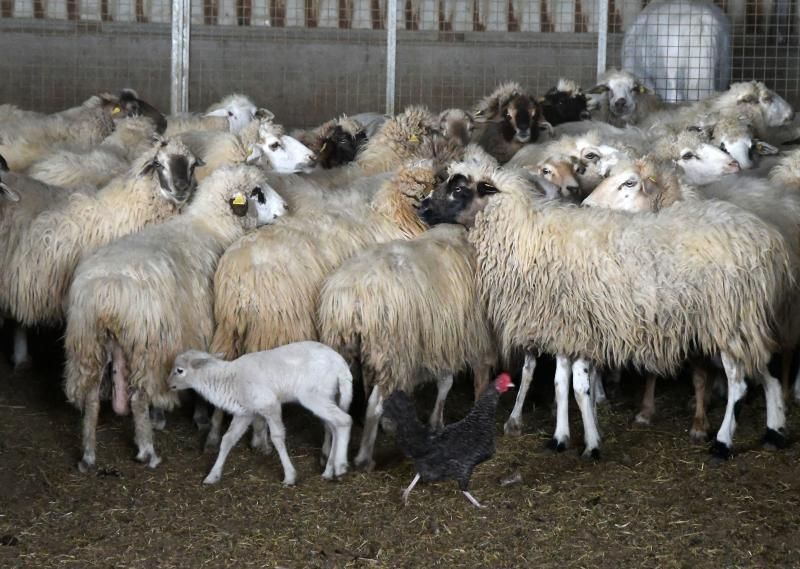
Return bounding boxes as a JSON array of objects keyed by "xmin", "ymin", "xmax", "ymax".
[{"xmin": 292, "ymin": 115, "xmax": 367, "ymax": 170}]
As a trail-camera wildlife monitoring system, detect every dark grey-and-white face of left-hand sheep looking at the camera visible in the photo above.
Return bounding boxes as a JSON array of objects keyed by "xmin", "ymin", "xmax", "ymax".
[{"xmin": 142, "ymin": 139, "xmax": 203, "ymax": 206}]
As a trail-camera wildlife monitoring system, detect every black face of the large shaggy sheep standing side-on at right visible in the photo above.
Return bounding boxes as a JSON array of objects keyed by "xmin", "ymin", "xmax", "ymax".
[{"xmin": 418, "ymin": 174, "xmax": 498, "ymax": 227}]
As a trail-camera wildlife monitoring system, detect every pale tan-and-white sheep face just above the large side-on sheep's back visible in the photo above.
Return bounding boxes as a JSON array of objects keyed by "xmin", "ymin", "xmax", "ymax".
[{"xmin": 583, "ymin": 167, "xmax": 661, "ymax": 211}]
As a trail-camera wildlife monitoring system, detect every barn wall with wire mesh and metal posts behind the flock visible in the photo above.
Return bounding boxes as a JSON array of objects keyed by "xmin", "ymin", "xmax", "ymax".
[{"xmin": 0, "ymin": 0, "xmax": 800, "ymax": 126}]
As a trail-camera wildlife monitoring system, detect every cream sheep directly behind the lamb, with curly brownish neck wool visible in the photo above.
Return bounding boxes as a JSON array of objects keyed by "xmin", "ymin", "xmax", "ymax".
[{"xmin": 206, "ymin": 146, "xmax": 466, "ymax": 448}]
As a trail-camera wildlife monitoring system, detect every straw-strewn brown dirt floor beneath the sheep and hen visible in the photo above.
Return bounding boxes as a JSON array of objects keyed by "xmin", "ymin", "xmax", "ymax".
[{"xmin": 0, "ymin": 330, "xmax": 800, "ymax": 569}]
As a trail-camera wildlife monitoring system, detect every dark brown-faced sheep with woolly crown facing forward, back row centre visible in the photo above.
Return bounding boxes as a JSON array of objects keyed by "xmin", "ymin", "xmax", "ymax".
[{"xmin": 472, "ymin": 82, "xmax": 550, "ymax": 164}]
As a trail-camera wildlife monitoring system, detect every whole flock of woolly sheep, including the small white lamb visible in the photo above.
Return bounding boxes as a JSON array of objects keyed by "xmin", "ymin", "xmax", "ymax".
[{"xmin": 0, "ymin": 70, "xmax": 800, "ymax": 484}]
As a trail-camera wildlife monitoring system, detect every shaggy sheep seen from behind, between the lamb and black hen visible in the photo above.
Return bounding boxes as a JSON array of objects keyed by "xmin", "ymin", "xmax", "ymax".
[{"xmin": 317, "ymin": 220, "xmax": 496, "ymax": 469}]
